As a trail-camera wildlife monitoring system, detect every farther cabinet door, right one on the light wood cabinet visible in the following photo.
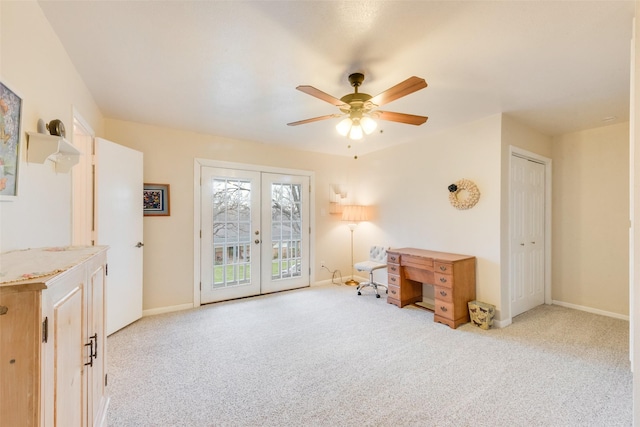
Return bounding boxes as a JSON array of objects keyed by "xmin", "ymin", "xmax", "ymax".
[{"xmin": 86, "ymin": 263, "xmax": 107, "ymax": 426}]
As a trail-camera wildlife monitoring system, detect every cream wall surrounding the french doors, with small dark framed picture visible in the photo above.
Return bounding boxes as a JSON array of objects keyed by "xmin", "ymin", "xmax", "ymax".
[{"xmin": 105, "ymin": 119, "xmax": 354, "ymax": 310}]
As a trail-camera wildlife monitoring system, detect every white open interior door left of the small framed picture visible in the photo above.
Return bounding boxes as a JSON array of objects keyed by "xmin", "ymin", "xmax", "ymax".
[{"xmin": 95, "ymin": 138, "xmax": 143, "ymax": 335}]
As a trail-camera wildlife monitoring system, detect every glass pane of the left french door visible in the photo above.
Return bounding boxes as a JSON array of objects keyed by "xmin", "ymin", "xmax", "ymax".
[{"xmin": 211, "ymin": 178, "xmax": 251, "ymax": 289}]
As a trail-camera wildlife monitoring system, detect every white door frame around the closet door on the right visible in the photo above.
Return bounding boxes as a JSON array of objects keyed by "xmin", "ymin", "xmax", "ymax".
[{"xmin": 508, "ymin": 145, "xmax": 553, "ymax": 327}]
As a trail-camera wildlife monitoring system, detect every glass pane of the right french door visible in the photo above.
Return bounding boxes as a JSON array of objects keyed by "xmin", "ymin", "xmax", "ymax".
[{"xmin": 271, "ymin": 183, "xmax": 302, "ymax": 280}]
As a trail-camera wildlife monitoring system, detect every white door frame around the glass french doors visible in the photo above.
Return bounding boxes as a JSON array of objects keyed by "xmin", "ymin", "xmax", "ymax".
[{"xmin": 193, "ymin": 157, "xmax": 316, "ymax": 307}]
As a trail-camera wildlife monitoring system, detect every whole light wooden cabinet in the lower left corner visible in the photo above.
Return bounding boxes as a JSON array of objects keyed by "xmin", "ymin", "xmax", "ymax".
[{"xmin": 0, "ymin": 247, "xmax": 108, "ymax": 427}]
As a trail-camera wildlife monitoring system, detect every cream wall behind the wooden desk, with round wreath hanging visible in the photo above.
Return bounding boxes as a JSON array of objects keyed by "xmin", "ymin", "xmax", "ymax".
[{"xmin": 356, "ymin": 114, "xmax": 501, "ymax": 319}]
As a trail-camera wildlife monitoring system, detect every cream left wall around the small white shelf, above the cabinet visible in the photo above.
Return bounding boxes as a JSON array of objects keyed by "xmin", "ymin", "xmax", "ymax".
[{"xmin": 0, "ymin": 1, "xmax": 102, "ymax": 252}]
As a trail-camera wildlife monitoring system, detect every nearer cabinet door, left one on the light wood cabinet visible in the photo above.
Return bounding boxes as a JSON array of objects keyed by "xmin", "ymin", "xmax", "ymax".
[{"xmin": 48, "ymin": 276, "xmax": 88, "ymax": 426}]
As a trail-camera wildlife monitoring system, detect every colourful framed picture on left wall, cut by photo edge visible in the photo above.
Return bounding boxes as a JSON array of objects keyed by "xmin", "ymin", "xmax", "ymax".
[{"xmin": 0, "ymin": 82, "xmax": 22, "ymax": 200}]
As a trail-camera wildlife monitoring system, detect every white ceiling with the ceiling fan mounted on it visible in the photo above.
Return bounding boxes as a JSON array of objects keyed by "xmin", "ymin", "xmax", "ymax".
[{"xmin": 40, "ymin": 0, "xmax": 634, "ymax": 156}]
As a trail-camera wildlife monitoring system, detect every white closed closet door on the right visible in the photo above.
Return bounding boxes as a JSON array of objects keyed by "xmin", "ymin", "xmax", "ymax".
[{"xmin": 509, "ymin": 155, "xmax": 546, "ymax": 316}]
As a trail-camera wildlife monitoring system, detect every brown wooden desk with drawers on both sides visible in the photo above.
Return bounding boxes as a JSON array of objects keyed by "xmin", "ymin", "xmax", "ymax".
[{"xmin": 387, "ymin": 248, "xmax": 476, "ymax": 329}]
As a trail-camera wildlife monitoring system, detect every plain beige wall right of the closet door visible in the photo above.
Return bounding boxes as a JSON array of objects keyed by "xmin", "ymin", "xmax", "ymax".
[{"xmin": 552, "ymin": 123, "xmax": 629, "ymax": 316}]
